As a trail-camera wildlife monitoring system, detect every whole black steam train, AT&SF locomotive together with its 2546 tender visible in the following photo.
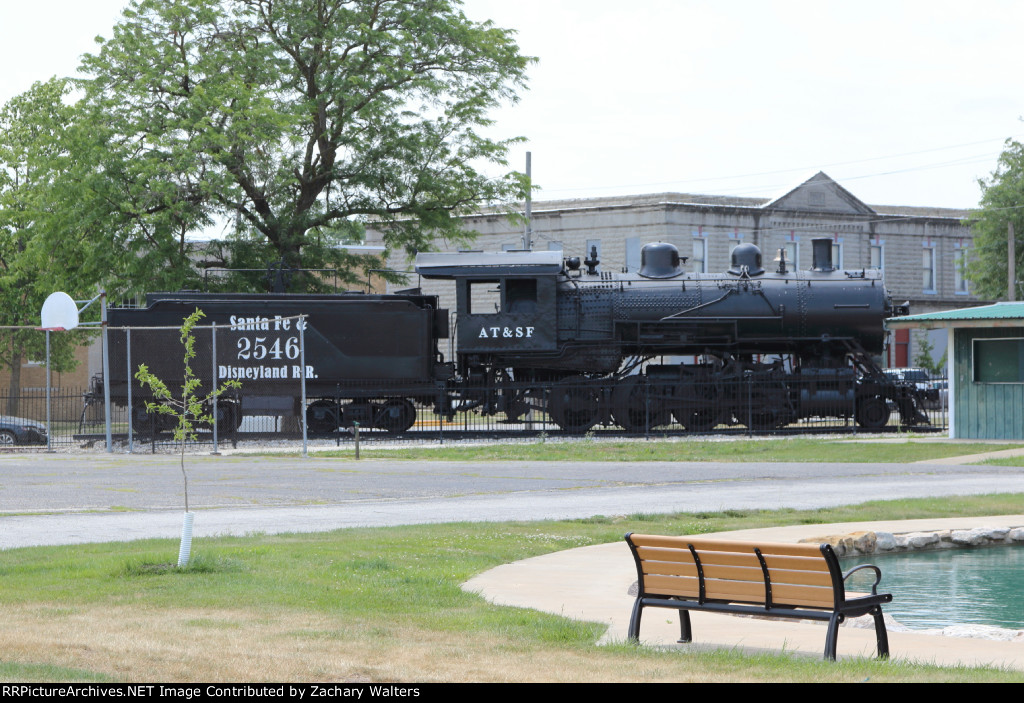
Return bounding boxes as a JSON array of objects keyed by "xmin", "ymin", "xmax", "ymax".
[{"xmin": 101, "ymin": 239, "xmax": 928, "ymax": 432}]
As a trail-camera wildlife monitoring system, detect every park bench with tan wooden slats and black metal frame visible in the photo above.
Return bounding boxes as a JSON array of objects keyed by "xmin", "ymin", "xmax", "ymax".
[{"xmin": 626, "ymin": 532, "xmax": 893, "ymax": 659}]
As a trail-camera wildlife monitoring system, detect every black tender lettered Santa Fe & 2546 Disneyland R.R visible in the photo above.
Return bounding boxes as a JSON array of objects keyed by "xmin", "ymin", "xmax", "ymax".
[{"xmin": 109, "ymin": 293, "xmax": 452, "ymax": 432}]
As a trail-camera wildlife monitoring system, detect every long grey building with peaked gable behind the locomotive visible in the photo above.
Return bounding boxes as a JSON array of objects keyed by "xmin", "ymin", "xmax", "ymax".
[{"xmin": 370, "ymin": 172, "xmax": 980, "ymax": 366}]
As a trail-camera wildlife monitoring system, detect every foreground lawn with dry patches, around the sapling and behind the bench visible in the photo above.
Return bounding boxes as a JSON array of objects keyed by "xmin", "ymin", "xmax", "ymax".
[{"xmin": 0, "ymin": 495, "xmax": 1024, "ymax": 683}]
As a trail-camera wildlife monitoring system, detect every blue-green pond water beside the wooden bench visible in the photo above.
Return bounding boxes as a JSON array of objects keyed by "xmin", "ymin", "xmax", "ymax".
[{"xmin": 840, "ymin": 546, "xmax": 1024, "ymax": 629}]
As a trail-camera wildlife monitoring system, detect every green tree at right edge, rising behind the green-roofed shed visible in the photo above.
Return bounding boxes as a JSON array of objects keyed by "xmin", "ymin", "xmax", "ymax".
[{"xmin": 967, "ymin": 139, "xmax": 1024, "ymax": 300}]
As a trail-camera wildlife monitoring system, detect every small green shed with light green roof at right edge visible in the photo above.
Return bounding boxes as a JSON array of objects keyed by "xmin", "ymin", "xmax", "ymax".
[{"xmin": 887, "ymin": 303, "xmax": 1024, "ymax": 439}]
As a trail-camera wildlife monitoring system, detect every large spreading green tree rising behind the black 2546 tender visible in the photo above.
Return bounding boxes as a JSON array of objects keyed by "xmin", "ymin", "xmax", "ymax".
[{"xmin": 82, "ymin": 0, "xmax": 531, "ymax": 288}]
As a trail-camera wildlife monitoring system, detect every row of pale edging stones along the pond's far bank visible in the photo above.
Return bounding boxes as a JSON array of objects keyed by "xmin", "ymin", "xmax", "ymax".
[{"xmin": 800, "ymin": 527, "xmax": 1024, "ymax": 557}]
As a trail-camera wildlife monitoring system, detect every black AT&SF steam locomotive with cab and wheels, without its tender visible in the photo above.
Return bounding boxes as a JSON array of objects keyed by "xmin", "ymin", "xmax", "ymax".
[{"xmin": 417, "ymin": 238, "xmax": 928, "ymax": 432}]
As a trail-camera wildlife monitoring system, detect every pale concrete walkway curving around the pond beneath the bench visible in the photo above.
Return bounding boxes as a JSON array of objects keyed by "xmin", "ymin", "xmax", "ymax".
[{"xmin": 464, "ymin": 515, "xmax": 1024, "ymax": 670}]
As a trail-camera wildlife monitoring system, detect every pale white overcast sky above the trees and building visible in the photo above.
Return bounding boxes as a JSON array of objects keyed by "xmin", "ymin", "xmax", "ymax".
[{"xmin": 0, "ymin": 0, "xmax": 1024, "ymax": 208}]
